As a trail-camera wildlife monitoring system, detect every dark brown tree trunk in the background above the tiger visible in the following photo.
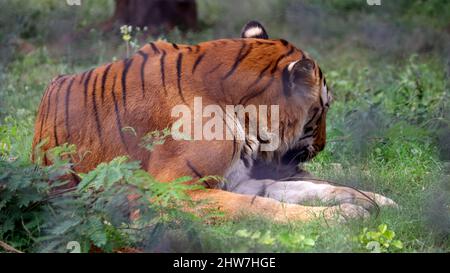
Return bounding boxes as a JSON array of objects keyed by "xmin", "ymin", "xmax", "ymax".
[{"xmin": 112, "ymin": 0, "xmax": 197, "ymax": 33}]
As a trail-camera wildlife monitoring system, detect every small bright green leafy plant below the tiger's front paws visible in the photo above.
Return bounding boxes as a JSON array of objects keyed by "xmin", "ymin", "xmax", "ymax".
[{"xmin": 358, "ymin": 224, "xmax": 403, "ymax": 253}]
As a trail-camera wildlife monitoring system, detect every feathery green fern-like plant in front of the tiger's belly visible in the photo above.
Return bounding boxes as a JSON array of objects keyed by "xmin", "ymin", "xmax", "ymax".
[{"xmin": 42, "ymin": 154, "xmax": 206, "ymax": 252}]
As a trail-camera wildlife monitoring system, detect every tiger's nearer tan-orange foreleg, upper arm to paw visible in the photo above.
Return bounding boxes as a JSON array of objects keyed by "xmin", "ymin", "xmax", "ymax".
[{"xmin": 147, "ymin": 141, "xmax": 368, "ymax": 222}]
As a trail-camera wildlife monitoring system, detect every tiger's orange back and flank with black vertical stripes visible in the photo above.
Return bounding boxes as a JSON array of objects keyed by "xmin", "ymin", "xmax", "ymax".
[{"xmin": 33, "ymin": 39, "xmax": 310, "ymax": 172}]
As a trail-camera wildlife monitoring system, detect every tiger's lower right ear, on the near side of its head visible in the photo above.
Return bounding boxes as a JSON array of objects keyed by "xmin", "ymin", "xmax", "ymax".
[{"xmin": 287, "ymin": 58, "xmax": 316, "ymax": 86}]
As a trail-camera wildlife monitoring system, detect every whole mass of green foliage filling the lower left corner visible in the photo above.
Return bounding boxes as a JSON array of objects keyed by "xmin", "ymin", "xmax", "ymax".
[{"xmin": 0, "ymin": 144, "xmax": 208, "ymax": 252}]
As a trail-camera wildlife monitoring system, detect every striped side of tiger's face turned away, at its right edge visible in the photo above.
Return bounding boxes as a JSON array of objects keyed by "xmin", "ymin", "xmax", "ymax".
[{"xmin": 282, "ymin": 57, "xmax": 332, "ymax": 165}]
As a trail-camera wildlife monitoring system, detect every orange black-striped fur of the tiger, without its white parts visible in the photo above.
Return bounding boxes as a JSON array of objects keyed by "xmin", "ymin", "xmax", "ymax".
[{"xmin": 33, "ymin": 21, "xmax": 338, "ymax": 220}]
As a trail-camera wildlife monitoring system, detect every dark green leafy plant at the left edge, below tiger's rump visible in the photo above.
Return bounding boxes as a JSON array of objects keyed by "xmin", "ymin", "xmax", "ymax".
[{"xmin": 0, "ymin": 140, "xmax": 81, "ymax": 250}]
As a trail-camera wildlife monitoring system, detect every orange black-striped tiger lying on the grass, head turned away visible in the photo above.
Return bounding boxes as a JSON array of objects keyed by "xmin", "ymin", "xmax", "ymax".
[{"xmin": 32, "ymin": 21, "xmax": 395, "ymax": 222}]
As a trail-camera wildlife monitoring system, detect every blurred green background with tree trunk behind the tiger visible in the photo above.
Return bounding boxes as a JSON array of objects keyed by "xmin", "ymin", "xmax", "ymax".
[{"xmin": 0, "ymin": 0, "xmax": 450, "ymax": 251}]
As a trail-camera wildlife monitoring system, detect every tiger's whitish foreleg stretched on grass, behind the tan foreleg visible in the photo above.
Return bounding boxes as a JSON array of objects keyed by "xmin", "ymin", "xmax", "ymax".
[{"xmin": 233, "ymin": 179, "xmax": 397, "ymax": 210}]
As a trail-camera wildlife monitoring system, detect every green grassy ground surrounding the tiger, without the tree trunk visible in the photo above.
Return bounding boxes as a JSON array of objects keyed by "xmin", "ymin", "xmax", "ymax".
[{"xmin": 0, "ymin": 0, "xmax": 450, "ymax": 252}]
